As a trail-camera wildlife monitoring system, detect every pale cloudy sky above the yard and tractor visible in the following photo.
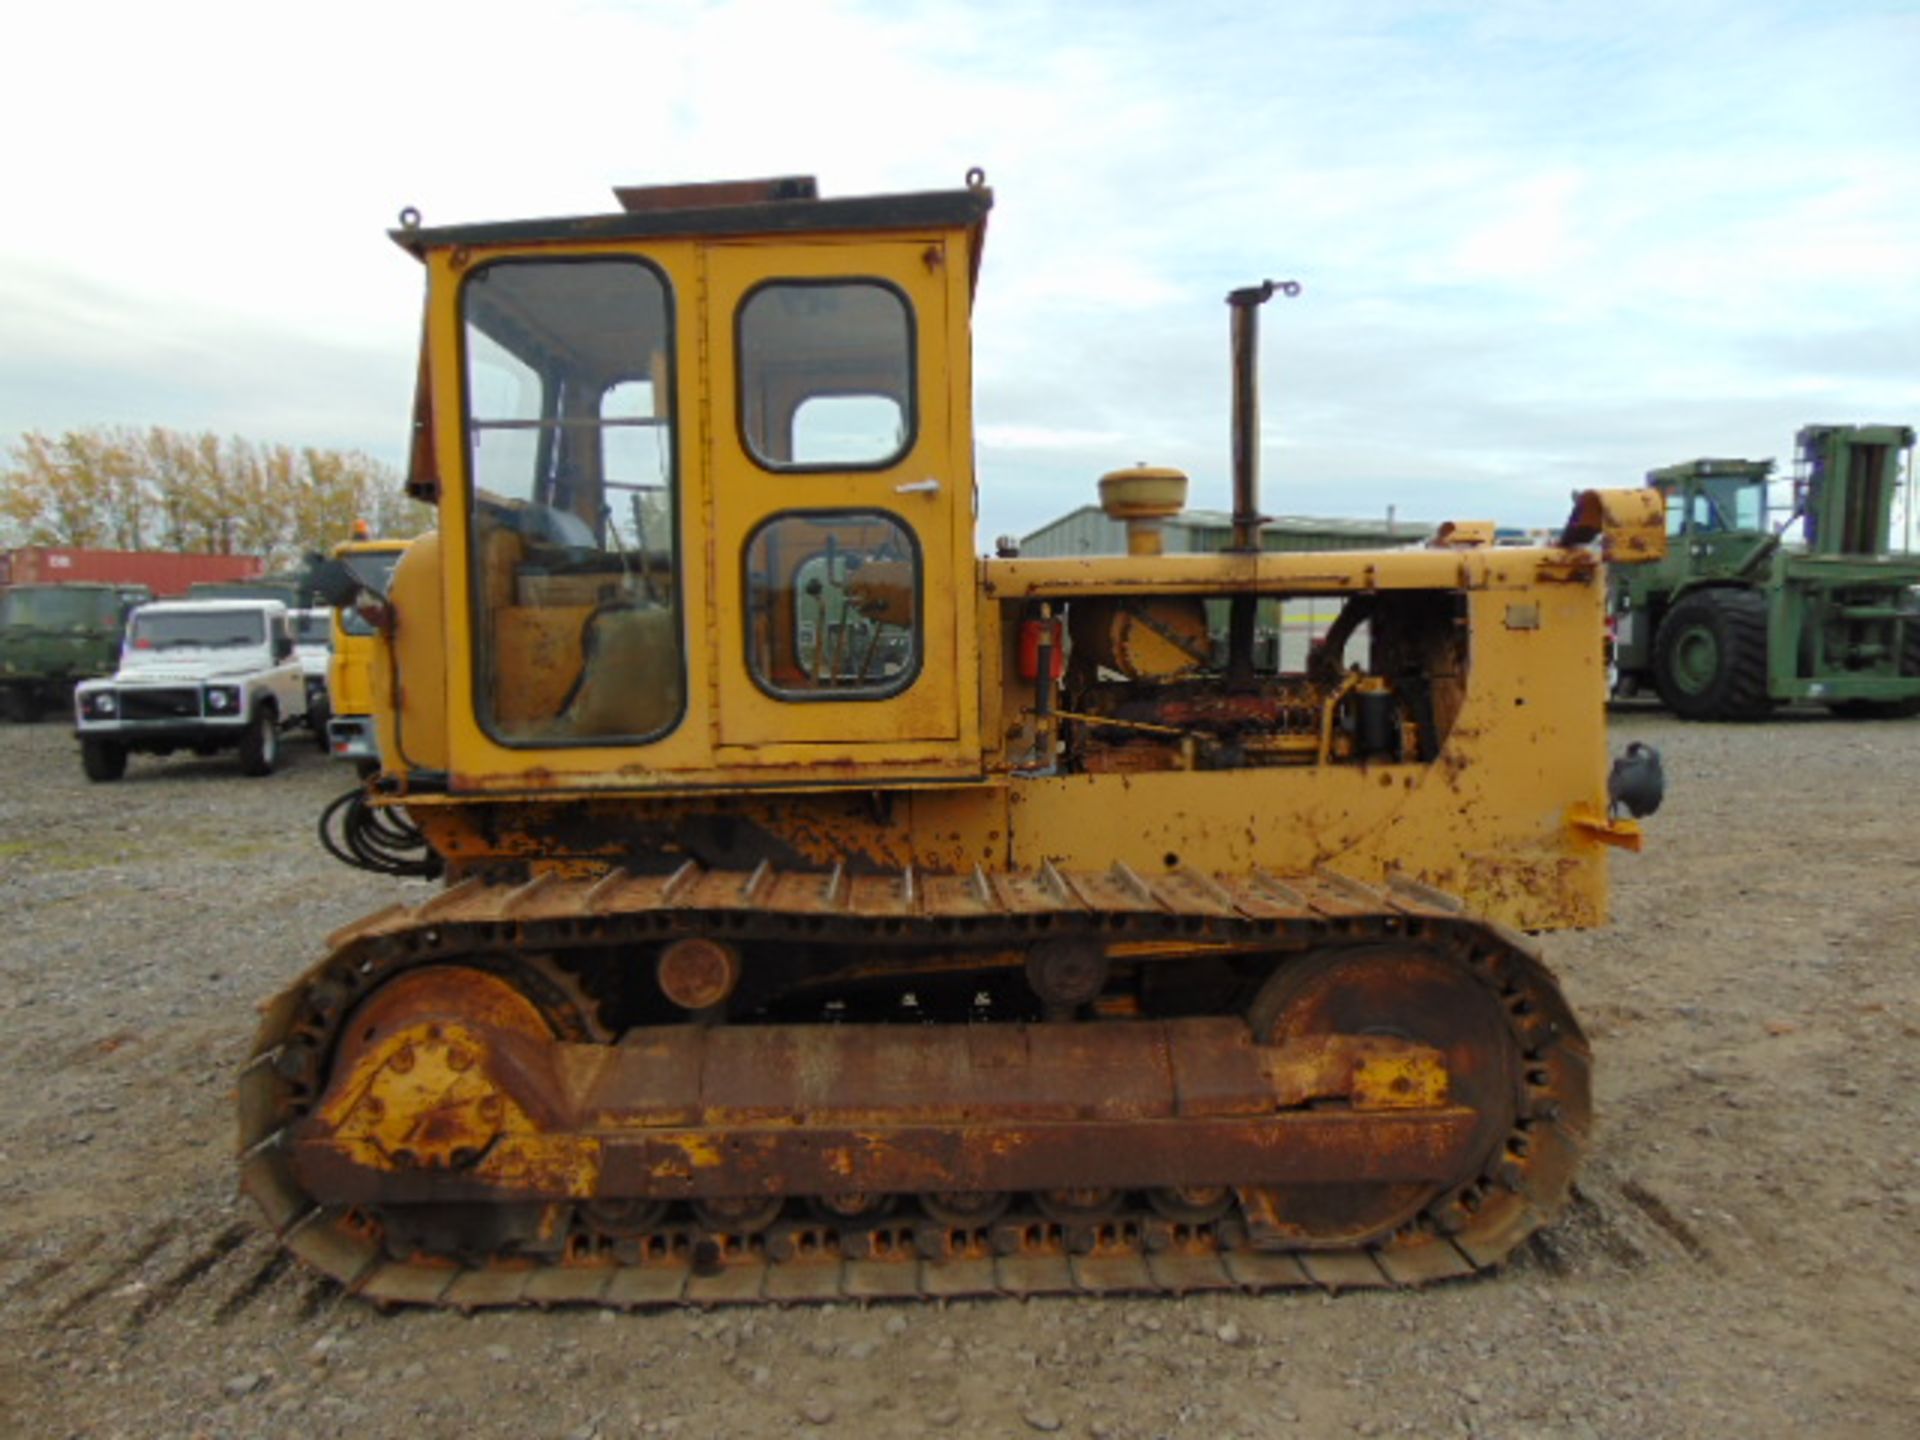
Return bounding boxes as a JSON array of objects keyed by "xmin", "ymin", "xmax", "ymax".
[{"xmin": 0, "ymin": 0, "xmax": 1920, "ymax": 543}]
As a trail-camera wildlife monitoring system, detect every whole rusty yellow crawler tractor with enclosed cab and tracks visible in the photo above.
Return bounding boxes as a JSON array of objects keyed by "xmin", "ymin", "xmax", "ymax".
[{"xmin": 240, "ymin": 173, "xmax": 1663, "ymax": 1308}]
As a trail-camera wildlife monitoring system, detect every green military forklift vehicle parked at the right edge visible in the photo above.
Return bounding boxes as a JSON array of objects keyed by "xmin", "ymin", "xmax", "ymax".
[{"xmin": 1611, "ymin": 424, "xmax": 1920, "ymax": 720}]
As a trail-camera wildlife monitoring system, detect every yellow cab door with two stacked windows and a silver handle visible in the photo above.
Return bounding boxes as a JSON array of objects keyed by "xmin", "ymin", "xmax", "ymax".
[{"xmin": 705, "ymin": 236, "xmax": 977, "ymax": 766}]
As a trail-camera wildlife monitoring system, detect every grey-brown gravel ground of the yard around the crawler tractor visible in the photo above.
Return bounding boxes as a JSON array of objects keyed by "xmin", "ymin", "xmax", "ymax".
[{"xmin": 0, "ymin": 710, "xmax": 1920, "ymax": 1440}]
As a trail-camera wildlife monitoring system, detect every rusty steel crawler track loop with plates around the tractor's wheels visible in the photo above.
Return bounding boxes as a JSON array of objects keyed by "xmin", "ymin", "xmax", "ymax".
[{"xmin": 240, "ymin": 862, "xmax": 1590, "ymax": 1309}]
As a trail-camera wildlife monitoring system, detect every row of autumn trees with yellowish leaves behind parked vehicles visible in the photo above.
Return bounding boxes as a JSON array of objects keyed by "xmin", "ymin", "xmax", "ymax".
[{"xmin": 0, "ymin": 424, "xmax": 434, "ymax": 568}]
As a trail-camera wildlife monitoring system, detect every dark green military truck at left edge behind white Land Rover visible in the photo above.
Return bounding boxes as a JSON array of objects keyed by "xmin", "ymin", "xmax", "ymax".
[{"xmin": 0, "ymin": 584, "xmax": 154, "ymax": 720}]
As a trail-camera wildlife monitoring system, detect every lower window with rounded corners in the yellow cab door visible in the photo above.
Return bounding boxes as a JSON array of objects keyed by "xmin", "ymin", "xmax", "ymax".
[{"xmin": 747, "ymin": 511, "xmax": 920, "ymax": 699}]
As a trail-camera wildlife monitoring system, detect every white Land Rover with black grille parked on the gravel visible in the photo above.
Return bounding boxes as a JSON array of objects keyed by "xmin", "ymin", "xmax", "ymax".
[{"xmin": 73, "ymin": 599, "xmax": 307, "ymax": 780}]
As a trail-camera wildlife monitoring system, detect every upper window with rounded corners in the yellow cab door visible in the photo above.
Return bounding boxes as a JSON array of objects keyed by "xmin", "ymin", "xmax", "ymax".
[{"xmin": 739, "ymin": 280, "xmax": 914, "ymax": 470}]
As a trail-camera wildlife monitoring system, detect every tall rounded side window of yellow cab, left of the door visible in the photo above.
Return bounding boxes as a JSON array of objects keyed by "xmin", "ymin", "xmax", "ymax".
[{"xmin": 461, "ymin": 257, "xmax": 685, "ymax": 745}]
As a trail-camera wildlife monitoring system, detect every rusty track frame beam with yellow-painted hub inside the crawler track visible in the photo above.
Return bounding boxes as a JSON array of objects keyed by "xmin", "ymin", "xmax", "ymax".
[{"xmin": 294, "ymin": 998, "xmax": 1475, "ymax": 1204}]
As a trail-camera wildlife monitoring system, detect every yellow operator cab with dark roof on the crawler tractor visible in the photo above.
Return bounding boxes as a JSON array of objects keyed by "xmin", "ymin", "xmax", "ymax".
[{"xmin": 396, "ymin": 180, "xmax": 991, "ymax": 802}]
